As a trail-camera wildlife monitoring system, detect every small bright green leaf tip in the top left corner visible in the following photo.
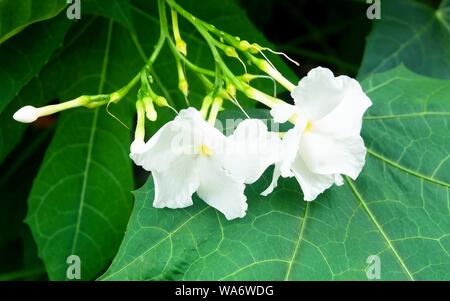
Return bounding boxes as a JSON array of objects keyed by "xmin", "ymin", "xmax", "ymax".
[{"xmin": 0, "ymin": 0, "xmax": 67, "ymax": 44}]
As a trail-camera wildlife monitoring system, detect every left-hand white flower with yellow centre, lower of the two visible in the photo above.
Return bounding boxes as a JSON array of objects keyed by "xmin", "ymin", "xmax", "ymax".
[{"xmin": 130, "ymin": 108, "xmax": 279, "ymax": 220}]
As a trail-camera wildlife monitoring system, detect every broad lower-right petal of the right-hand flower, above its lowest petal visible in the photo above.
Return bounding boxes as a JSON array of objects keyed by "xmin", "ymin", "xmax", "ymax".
[{"xmin": 300, "ymin": 132, "xmax": 366, "ymax": 179}]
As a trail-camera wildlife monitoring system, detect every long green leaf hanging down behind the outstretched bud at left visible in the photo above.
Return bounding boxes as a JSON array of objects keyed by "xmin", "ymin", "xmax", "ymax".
[{"xmin": 26, "ymin": 20, "xmax": 135, "ymax": 280}]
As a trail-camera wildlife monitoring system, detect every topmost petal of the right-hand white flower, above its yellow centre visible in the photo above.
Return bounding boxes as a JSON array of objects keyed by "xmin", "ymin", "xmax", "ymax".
[{"xmin": 291, "ymin": 67, "xmax": 354, "ymax": 121}]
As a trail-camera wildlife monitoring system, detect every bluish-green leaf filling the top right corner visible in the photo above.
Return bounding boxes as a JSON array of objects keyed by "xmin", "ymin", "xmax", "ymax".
[{"xmin": 360, "ymin": 0, "xmax": 450, "ymax": 79}]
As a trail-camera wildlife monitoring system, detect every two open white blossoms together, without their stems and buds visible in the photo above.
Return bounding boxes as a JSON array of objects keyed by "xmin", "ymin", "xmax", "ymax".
[{"xmin": 130, "ymin": 67, "xmax": 371, "ymax": 219}]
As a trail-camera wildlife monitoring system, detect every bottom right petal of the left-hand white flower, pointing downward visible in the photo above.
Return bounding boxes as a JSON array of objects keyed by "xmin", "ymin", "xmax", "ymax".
[{"xmin": 197, "ymin": 158, "xmax": 247, "ymax": 220}]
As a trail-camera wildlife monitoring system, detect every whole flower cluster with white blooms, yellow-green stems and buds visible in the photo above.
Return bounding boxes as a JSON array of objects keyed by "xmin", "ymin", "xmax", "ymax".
[{"xmin": 13, "ymin": 0, "xmax": 371, "ymax": 219}]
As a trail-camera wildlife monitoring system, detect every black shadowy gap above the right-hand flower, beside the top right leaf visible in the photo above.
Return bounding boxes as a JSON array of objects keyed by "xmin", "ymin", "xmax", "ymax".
[{"xmin": 238, "ymin": 0, "xmax": 440, "ymax": 77}]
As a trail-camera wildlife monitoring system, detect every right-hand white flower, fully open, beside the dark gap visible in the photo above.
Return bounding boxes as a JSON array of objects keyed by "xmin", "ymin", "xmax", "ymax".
[{"xmin": 263, "ymin": 67, "xmax": 372, "ymax": 201}]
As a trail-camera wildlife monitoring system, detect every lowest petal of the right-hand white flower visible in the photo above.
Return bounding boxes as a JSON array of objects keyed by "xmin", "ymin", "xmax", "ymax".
[{"xmin": 292, "ymin": 156, "xmax": 335, "ymax": 201}]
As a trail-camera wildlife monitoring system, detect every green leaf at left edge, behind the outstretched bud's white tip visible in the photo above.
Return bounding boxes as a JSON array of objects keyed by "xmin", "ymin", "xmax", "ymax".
[{"xmin": 0, "ymin": 16, "xmax": 71, "ymax": 163}]
